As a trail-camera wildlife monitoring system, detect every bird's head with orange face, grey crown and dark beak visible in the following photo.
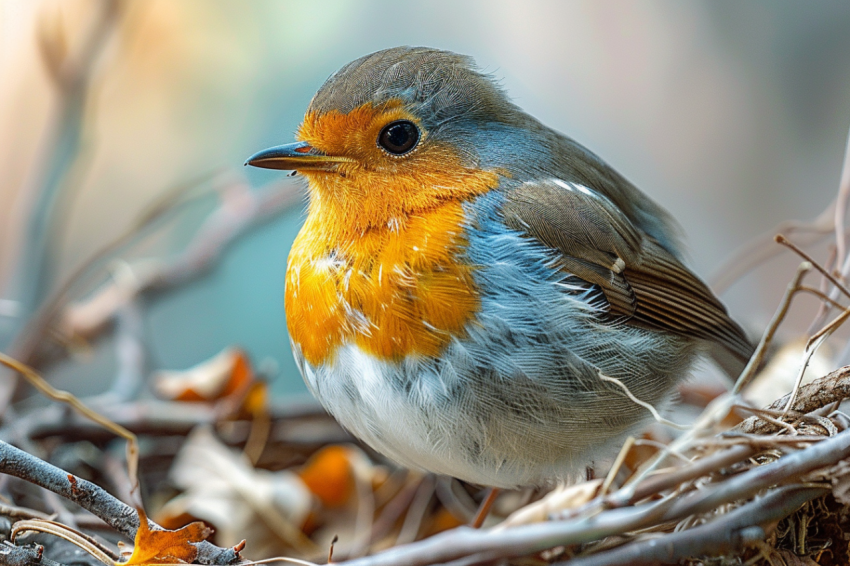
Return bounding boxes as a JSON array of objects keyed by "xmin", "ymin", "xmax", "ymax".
[{"xmin": 248, "ymin": 47, "xmax": 532, "ymax": 229}]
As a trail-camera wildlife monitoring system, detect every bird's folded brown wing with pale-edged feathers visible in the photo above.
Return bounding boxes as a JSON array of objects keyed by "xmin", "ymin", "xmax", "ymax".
[{"xmin": 502, "ymin": 180, "xmax": 753, "ymax": 360}]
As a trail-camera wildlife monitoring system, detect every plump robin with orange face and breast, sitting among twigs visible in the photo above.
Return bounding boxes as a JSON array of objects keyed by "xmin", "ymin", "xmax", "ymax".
[{"xmin": 246, "ymin": 47, "xmax": 753, "ymax": 488}]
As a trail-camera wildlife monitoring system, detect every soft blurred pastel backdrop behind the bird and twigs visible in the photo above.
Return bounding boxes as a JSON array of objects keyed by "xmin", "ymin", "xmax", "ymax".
[{"xmin": 0, "ymin": 0, "xmax": 850, "ymax": 397}]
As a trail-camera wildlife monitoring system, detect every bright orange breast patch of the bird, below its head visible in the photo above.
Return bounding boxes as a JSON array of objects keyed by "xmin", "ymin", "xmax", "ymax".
[{"xmin": 286, "ymin": 201, "xmax": 479, "ymax": 365}]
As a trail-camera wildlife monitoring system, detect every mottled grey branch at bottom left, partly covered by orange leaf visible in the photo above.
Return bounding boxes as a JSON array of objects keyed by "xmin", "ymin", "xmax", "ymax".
[{"xmin": 0, "ymin": 440, "xmax": 241, "ymax": 564}]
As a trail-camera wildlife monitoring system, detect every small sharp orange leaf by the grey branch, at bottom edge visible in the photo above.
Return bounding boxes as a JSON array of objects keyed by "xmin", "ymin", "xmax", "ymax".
[{"xmin": 116, "ymin": 507, "xmax": 212, "ymax": 566}]
